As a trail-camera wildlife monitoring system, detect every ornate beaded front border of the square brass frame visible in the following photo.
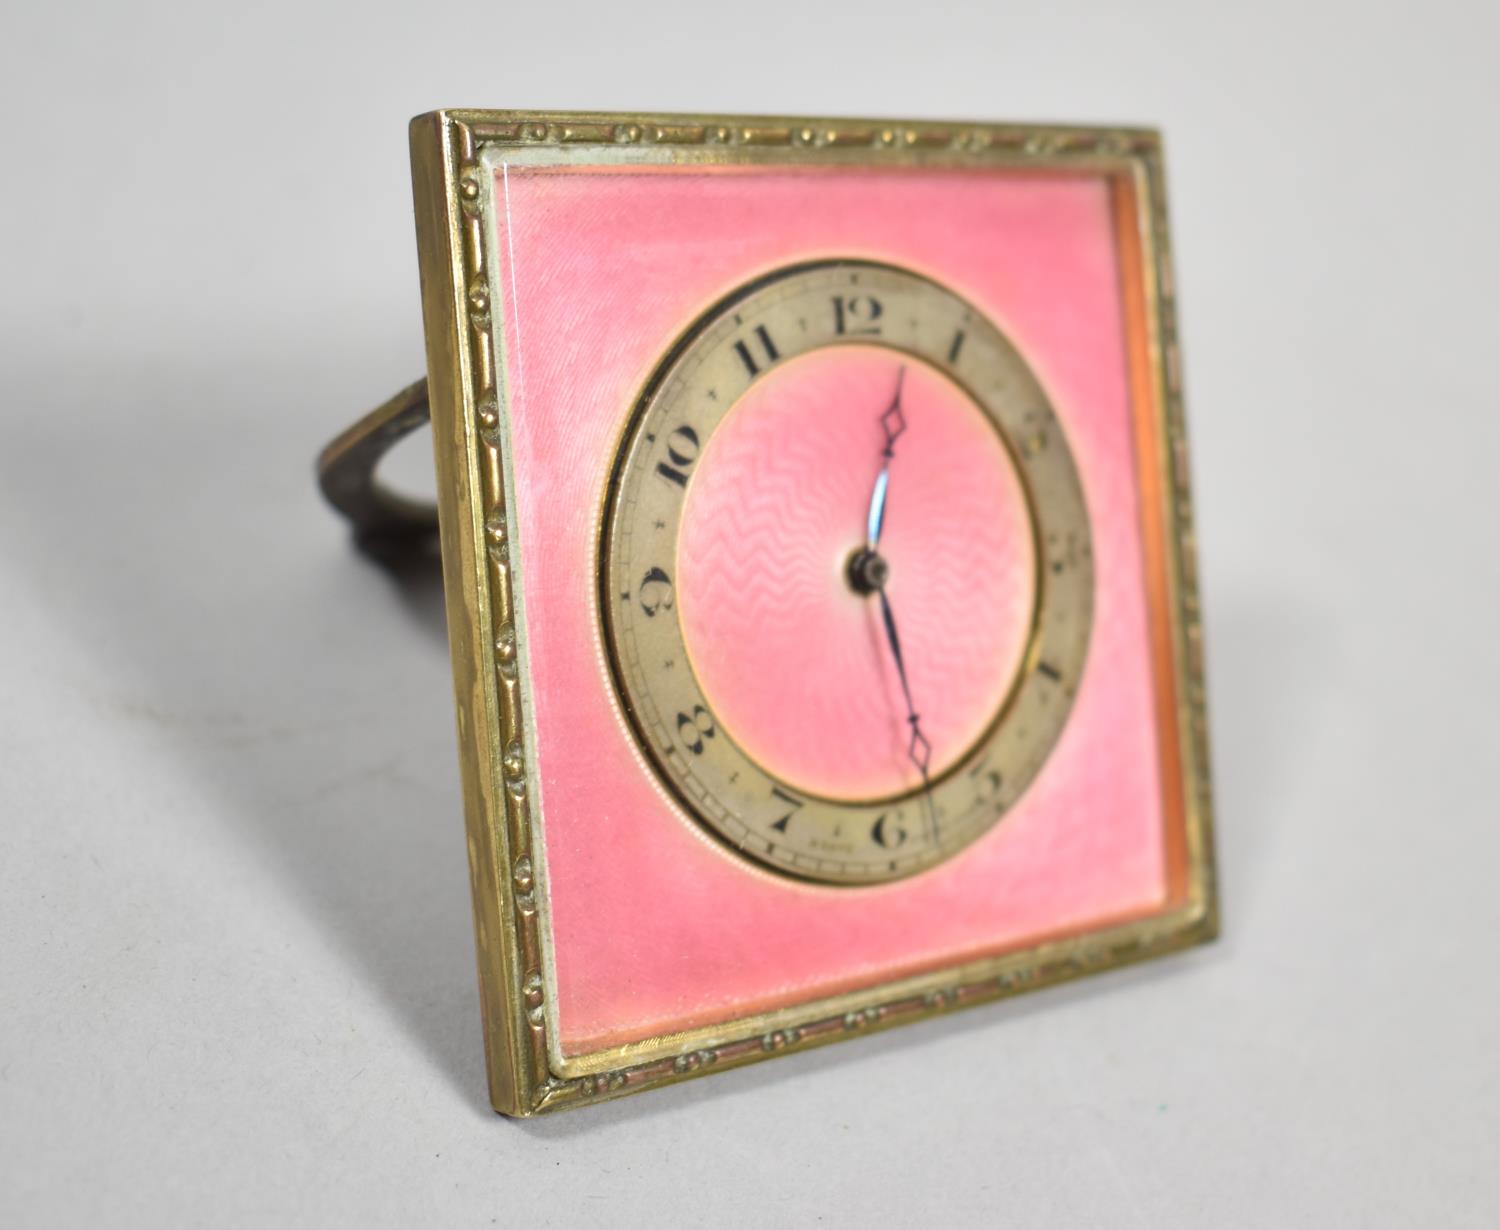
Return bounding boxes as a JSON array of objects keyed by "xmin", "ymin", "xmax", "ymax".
[{"xmin": 423, "ymin": 111, "xmax": 1218, "ymax": 1115}]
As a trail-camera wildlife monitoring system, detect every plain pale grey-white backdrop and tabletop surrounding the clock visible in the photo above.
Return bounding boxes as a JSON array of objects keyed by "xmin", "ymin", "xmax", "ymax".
[{"xmin": 0, "ymin": 0, "xmax": 1500, "ymax": 1227}]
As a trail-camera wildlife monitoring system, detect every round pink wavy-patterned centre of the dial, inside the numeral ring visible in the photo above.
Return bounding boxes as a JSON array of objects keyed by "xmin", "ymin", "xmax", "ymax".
[{"xmin": 677, "ymin": 345, "xmax": 1037, "ymax": 800}]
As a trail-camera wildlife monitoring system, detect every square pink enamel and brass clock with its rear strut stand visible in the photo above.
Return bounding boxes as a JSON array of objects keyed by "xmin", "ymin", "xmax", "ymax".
[{"xmin": 323, "ymin": 111, "xmax": 1217, "ymax": 1115}]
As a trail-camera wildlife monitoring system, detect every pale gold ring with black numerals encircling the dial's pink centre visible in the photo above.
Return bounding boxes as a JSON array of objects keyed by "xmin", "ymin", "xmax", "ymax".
[{"xmin": 600, "ymin": 261, "xmax": 1094, "ymax": 884}]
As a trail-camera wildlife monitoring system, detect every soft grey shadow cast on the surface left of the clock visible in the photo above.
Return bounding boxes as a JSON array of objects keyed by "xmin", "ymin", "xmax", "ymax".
[{"xmin": 0, "ymin": 356, "xmax": 489, "ymax": 1116}]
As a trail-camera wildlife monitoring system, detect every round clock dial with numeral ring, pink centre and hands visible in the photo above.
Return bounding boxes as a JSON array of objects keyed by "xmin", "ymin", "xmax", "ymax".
[{"xmin": 600, "ymin": 261, "xmax": 1094, "ymax": 884}]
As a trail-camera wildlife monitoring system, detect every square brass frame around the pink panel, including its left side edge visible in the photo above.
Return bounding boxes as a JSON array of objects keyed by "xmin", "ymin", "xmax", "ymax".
[{"xmin": 411, "ymin": 111, "xmax": 1218, "ymax": 1115}]
